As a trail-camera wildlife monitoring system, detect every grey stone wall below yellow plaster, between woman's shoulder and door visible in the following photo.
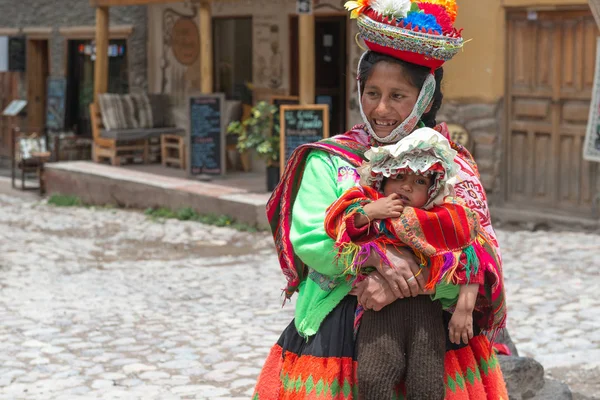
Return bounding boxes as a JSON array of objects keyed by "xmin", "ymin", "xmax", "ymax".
[{"xmin": 437, "ymin": 100, "xmax": 504, "ymax": 200}]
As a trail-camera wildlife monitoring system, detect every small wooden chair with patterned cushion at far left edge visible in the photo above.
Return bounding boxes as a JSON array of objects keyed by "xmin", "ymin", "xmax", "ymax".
[{"xmin": 11, "ymin": 127, "xmax": 51, "ymax": 194}]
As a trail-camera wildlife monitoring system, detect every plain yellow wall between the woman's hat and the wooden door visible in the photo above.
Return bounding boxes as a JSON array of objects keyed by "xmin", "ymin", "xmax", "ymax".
[{"xmin": 444, "ymin": 0, "xmax": 588, "ymax": 102}]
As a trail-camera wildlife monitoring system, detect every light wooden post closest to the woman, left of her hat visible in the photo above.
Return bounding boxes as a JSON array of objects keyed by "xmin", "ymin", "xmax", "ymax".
[{"xmin": 298, "ymin": 14, "xmax": 315, "ymax": 104}]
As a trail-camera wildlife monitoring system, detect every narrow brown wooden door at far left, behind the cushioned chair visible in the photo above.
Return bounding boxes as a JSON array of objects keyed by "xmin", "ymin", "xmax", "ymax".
[{"xmin": 27, "ymin": 39, "xmax": 49, "ymax": 132}]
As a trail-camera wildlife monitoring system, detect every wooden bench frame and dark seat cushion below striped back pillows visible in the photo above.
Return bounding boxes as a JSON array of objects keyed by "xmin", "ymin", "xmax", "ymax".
[{"xmin": 90, "ymin": 103, "xmax": 185, "ymax": 165}]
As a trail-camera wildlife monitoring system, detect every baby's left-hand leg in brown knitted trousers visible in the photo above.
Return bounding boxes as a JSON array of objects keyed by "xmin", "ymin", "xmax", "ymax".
[{"xmin": 357, "ymin": 300, "xmax": 407, "ymax": 400}]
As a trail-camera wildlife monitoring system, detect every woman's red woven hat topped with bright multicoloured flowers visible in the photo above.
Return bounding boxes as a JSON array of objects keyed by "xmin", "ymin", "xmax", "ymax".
[{"xmin": 345, "ymin": 0, "xmax": 464, "ymax": 69}]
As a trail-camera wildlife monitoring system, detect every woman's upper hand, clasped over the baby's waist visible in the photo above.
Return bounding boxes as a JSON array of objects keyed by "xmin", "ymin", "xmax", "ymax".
[{"xmin": 375, "ymin": 248, "xmax": 427, "ymax": 299}]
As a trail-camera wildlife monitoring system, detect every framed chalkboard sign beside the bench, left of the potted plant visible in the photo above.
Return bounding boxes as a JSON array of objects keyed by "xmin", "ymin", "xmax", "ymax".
[{"xmin": 188, "ymin": 93, "xmax": 225, "ymax": 177}]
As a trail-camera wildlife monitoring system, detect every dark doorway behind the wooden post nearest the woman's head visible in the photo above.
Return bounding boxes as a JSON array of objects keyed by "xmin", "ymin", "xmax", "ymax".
[{"xmin": 290, "ymin": 15, "xmax": 347, "ymax": 136}]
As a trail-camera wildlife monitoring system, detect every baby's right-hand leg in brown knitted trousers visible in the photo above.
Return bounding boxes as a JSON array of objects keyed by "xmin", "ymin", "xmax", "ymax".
[{"xmin": 406, "ymin": 296, "xmax": 446, "ymax": 400}]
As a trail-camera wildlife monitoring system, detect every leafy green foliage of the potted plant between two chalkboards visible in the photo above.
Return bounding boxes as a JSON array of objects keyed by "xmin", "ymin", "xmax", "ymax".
[{"xmin": 227, "ymin": 101, "xmax": 279, "ymax": 165}]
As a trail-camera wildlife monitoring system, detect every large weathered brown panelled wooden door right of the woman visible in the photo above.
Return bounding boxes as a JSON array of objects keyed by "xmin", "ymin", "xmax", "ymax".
[{"xmin": 504, "ymin": 10, "xmax": 600, "ymax": 217}]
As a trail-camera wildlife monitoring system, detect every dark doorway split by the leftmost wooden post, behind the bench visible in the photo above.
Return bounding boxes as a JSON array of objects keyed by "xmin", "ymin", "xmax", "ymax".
[{"xmin": 65, "ymin": 39, "xmax": 129, "ymax": 138}]
